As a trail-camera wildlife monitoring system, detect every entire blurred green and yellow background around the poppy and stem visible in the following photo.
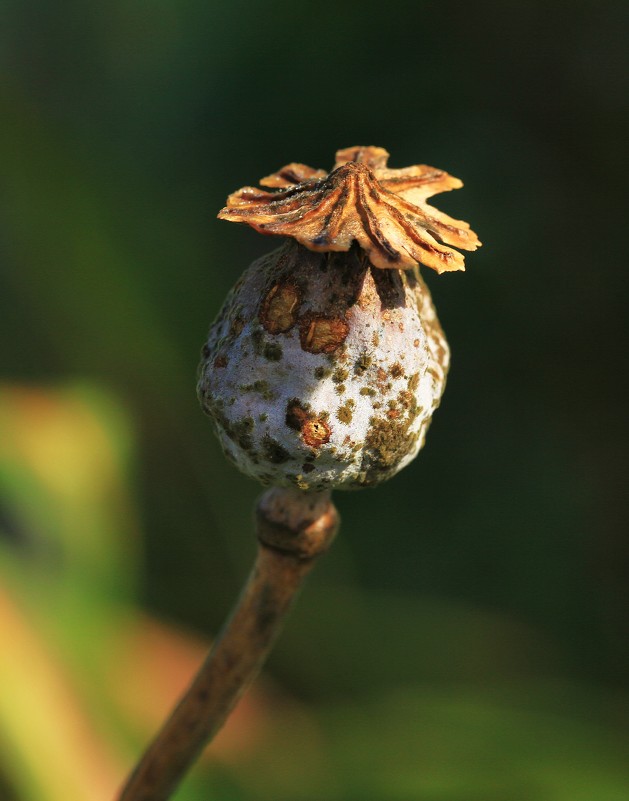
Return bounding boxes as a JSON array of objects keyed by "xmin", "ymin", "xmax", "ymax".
[{"xmin": 0, "ymin": 0, "xmax": 629, "ymax": 801}]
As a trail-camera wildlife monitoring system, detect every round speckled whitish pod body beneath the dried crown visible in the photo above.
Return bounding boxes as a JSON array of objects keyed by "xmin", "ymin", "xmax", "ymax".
[{"xmin": 199, "ymin": 241, "xmax": 449, "ymax": 491}]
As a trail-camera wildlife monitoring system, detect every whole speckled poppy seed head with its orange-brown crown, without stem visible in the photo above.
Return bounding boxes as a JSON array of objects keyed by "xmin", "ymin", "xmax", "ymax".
[{"xmin": 198, "ymin": 147, "xmax": 480, "ymax": 491}]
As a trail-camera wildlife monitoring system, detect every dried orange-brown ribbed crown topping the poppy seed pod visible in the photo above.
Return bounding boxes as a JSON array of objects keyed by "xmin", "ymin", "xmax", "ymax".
[{"xmin": 219, "ymin": 147, "xmax": 480, "ymax": 273}]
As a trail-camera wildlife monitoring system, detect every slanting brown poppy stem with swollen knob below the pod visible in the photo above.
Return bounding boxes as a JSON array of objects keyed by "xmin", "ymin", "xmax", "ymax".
[{"xmin": 114, "ymin": 488, "xmax": 339, "ymax": 801}]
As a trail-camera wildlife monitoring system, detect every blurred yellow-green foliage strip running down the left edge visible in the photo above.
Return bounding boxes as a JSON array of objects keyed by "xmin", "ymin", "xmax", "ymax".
[{"xmin": 0, "ymin": 384, "xmax": 138, "ymax": 801}]
